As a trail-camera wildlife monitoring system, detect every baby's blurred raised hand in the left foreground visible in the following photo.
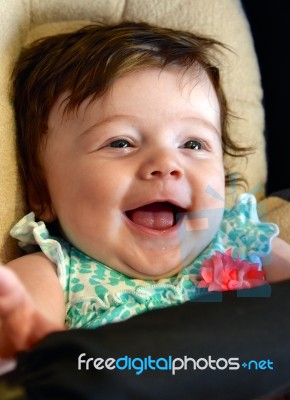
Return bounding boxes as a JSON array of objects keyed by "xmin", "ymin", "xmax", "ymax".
[{"xmin": 0, "ymin": 266, "xmax": 63, "ymax": 358}]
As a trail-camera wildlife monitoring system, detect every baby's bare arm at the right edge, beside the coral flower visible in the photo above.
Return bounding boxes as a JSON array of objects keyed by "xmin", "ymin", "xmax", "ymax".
[{"xmin": 264, "ymin": 238, "xmax": 290, "ymax": 282}]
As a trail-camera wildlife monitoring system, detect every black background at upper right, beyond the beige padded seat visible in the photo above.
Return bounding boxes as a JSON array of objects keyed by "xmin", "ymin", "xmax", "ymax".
[{"xmin": 242, "ymin": 0, "xmax": 290, "ymax": 195}]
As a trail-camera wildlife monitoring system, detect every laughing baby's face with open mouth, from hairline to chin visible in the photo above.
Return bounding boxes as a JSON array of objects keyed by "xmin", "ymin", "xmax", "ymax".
[{"xmin": 43, "ymin": 67, "xmax": 224, "ymax": 279}]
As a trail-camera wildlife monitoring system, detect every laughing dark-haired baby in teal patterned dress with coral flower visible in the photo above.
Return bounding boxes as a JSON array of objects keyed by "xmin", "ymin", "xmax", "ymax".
[{"xmin": 0, "ymin": 22, "xmax": 290, "ymax": 357}]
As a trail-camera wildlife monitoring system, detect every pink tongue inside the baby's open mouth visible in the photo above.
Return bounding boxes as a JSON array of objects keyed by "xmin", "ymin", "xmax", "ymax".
[{"xmin": 128, "ymin": 203, "xmax": 174, "ymax": 229}]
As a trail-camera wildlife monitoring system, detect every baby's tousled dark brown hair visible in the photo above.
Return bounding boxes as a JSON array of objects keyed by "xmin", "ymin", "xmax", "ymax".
[{"xmin": 12, "ymin": 22, "xmax": 247, "ymax": 217}]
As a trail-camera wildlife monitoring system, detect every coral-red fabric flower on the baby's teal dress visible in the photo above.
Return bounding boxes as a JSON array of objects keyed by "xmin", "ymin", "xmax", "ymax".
[{"xmin": 198, "ymin": 249, "xmax": 266, "ymax": 292}]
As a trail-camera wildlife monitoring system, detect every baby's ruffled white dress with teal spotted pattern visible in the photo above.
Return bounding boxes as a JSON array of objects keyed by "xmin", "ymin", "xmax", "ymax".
[{"xmin": 11, "ymin": 194, "xmax": 279, "ymax": 328}]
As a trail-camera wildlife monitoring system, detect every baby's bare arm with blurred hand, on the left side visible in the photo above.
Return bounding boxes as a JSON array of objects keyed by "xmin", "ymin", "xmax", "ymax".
[{"xmin": 0, "ymin": 253, "xmax": 65, "ymax": 358}]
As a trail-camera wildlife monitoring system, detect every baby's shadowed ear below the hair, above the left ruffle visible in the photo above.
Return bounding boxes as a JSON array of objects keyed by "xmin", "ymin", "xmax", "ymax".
[{"xmin": 27, "ymin": 183, "xmax": 56, "ymax": 222}]
